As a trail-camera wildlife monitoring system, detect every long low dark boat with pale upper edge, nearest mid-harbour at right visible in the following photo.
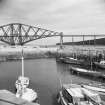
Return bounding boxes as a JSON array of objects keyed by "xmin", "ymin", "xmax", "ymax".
[{"xmin": 70, "ymin": 66, "xmax": 105, "ymax": 79}]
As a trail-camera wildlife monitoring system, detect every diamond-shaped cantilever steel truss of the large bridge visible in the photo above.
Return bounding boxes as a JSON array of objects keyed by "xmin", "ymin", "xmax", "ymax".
[{"xmin": 0, "ymin": 23, "xmax": 61, "ymax": 45}]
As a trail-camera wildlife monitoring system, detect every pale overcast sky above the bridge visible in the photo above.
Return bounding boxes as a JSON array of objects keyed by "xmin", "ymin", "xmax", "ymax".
[{"xmin": 0, "ymin": 0, "xmax": 105, "ymax": 42}]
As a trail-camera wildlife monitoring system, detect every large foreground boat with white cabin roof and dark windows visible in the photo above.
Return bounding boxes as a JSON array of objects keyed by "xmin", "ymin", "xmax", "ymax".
[{"xmin": 57, "ymin": 84, "xmax": 101, "ymax": 105}]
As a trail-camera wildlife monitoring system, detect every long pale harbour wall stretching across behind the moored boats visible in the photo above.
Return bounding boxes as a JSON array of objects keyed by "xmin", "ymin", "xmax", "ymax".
[{"xmin": 0, "ymin": 45, "xmax": 105, "ymax": 61}]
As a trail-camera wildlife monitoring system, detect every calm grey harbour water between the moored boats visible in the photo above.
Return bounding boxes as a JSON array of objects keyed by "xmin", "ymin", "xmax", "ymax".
[{"xmin": 0, "ymin": 59, "xmax": 103, "ymax": 105}]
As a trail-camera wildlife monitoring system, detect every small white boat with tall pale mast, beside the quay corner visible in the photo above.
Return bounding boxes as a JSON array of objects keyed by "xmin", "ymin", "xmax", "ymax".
[{"xmin": 15, "ymin": 49, "xmax": 38, "ymax": 102}]
